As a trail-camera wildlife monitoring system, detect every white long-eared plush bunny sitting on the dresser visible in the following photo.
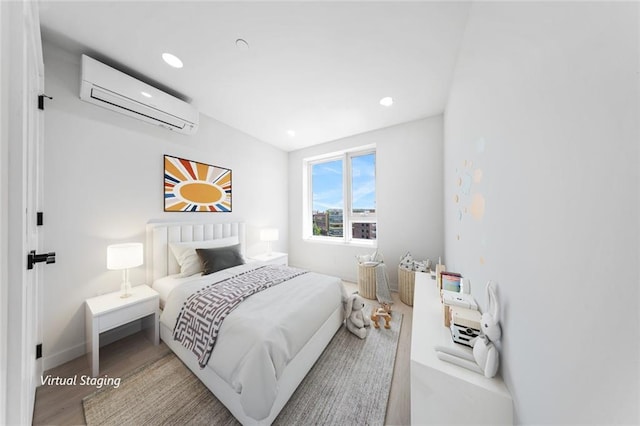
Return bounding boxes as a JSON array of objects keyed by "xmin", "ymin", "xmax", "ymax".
[{"xmin": 435, "ymin": 281, "xmax": 502, "ymax": 378}]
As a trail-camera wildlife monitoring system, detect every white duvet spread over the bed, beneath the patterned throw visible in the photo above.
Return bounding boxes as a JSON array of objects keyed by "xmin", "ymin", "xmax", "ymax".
[{"xmin": 160, "ymin": 263, "xmax": 345, "ymax": 420}]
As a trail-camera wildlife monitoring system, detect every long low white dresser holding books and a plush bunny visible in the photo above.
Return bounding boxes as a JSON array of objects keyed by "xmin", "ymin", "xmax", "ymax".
[{"xmin": 410, "ymin": 272, "xmax": 513, "ymax": 425}]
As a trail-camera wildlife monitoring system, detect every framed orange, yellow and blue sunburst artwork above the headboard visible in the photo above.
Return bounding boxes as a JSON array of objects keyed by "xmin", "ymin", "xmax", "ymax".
[{"xmin": 164, "ymin": 155, "xmax": 231, "ymax": 212}]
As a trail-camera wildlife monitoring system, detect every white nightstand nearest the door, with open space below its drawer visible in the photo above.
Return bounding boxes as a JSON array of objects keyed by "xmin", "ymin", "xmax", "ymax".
[{"xmin": 85, "ymin": 285, "xmax": 160, "ymax": 377}]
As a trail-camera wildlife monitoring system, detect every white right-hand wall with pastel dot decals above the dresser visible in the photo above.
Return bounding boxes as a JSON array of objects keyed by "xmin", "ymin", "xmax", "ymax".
[{"xmin": 444, "ymin": 2, "xmax": 640, "ymax": 424}]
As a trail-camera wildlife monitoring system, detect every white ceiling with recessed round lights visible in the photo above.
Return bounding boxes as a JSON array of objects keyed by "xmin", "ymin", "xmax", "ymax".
[{"xmin": 40, "ymin": 0, "xmax": 469, "ymax": 151}]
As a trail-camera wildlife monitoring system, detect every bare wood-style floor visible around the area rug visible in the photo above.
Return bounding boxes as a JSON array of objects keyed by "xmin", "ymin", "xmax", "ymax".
[{"xmin": 33, "ymin": 282, "xmax": 413, "ymax": 425}]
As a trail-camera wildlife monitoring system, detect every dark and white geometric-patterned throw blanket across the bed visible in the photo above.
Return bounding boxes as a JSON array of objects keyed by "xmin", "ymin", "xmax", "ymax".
[{"xmin": 173, "ymin": 265, "xmax": 307, "ymax": 368}]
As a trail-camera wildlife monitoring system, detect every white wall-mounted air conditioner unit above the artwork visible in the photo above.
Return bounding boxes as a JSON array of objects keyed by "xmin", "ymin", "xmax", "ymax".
[{"xmin": 80, "ymin": 55, "xmax": 198, "ymax": 134}]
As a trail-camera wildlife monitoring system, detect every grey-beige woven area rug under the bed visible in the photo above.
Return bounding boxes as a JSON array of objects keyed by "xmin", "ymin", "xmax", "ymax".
[{"xmin": 82, "ymin": 308, "xmax": 402, "ymax": 426}]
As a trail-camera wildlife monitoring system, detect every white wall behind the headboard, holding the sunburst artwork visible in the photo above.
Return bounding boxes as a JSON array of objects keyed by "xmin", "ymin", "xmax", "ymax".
[{"xmin": 43, "ymin": 44, "xmax": 288, "ymax": 368}]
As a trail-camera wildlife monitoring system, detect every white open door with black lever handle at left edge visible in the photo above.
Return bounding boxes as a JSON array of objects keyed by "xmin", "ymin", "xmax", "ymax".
[{"xmin": 0, "ymin": 0, "xmax": 44, "ymax": 424}]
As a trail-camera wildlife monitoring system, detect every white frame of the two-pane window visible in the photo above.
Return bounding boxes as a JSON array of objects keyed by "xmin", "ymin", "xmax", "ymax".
[{"xmin": 302, "ymin": 145, "xmax": 378, "ymax": 247}]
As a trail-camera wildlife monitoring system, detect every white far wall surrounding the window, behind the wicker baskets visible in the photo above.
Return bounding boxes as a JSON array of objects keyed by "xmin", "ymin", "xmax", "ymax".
[{"xmin": 289, "ymin": 116, "xmax": 444, "ymax": 288}]
